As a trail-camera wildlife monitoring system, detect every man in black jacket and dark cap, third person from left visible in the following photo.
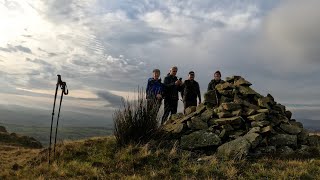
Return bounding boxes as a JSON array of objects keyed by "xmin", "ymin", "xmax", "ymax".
[{"xmin": 181, "ymin": 71, "xmax": 201, "ymax": 111}]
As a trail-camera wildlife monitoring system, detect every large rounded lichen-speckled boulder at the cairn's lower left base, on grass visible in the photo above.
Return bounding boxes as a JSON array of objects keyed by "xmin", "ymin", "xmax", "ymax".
[{"xmin": 180, "ymin": 130, "xmax": 221, "ymax": 149}]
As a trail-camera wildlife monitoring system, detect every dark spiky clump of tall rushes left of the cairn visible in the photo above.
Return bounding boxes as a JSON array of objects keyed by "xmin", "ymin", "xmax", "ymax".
[{"xmin": 113, "ymin": 89, "xmax": 158, "ymax": 146}]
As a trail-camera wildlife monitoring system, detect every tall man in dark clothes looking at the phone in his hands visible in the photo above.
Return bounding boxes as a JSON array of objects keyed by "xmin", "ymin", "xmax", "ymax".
[{"xmin": 161, "ymin": 66, "xmax": 182, "ymax": 124}]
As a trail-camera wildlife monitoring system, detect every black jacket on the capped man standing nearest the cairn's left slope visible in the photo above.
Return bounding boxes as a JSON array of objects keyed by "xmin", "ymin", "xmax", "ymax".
[{"xmin": 181, "ymin": 80, "xmax": 201, "ymax": 102}]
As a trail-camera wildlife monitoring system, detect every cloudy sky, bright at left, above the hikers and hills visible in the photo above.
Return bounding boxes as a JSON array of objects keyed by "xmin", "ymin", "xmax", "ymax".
[{"xmin": 0, "ymin": 0, "xmax": 320, "ymax": 126}]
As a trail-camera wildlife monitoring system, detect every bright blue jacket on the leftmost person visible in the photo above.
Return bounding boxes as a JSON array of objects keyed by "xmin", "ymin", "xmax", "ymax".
[{"xmin": 146, "ymin": 78, "xmax": 164, "ymax": 99}]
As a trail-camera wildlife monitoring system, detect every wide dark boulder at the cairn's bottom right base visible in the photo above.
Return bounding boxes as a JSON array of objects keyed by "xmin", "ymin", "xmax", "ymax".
[{"xmin": 269, "ymin": 134, "xmax": 298, "ymax": 147}]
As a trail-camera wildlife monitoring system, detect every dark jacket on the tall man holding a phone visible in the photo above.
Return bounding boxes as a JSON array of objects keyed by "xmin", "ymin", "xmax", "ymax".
[{"xmin": 163, "ymin": 74, "xmax": 181, "ymax": 100}]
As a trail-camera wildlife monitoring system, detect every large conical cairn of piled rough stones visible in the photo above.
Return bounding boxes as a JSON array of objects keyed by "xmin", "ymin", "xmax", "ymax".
[{"xmin": 163, "ymin": 76, "xmax": 320, "ymax": 159}]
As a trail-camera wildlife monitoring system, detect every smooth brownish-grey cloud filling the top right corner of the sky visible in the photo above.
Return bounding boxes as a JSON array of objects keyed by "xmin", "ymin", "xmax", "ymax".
[{"xmin": 261, "ymin": 0, "xmax": 320, "ymax": 65}]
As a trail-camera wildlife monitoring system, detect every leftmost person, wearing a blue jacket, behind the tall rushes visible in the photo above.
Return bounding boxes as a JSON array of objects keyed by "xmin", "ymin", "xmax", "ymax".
[{"xmin": 146, "ymin": 69, "xmax": 164, "ymax": 114}]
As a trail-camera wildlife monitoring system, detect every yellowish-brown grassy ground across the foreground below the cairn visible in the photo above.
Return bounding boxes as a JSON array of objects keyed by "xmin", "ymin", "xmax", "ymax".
[{"xmin": 0, "ymin": 136, "xmax": 320, "ymax": 179}]
